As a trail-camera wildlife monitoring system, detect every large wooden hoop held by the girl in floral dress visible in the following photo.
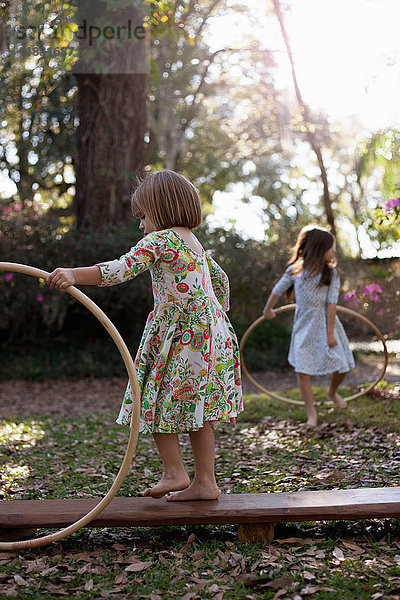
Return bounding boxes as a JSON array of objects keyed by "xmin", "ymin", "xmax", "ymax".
[{"xmin": 0, "ymin": 262, "xmax": 140, "ymax": 550}]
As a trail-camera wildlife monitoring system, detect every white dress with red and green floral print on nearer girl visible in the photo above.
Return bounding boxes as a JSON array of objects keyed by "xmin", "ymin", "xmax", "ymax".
[{"xmin": 98, "ymin": 229, "xmax": 243, "ymax": 433}]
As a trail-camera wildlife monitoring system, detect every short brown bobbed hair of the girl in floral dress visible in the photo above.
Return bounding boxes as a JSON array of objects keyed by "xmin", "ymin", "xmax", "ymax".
[{"xmin": 131, "ymin": 169, "xmax": 201, "ymax": 231}]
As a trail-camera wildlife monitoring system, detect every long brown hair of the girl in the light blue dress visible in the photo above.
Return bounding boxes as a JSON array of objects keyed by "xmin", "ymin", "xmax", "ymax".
[{"xmin": 285, "ymin": 225, "xmax": 337, "ymax": 300}]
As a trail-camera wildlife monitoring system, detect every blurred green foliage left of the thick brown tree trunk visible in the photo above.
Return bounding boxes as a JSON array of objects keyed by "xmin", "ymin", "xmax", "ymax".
[{"xmin": 0, "ymin": 0, "xmax": 76, "ymax": 205}]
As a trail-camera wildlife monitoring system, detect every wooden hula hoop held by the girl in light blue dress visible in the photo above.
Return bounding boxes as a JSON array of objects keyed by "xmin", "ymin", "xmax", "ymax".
[{"xmin": 240, "ymin": 304, "xmax": 389, "ymax": 406}]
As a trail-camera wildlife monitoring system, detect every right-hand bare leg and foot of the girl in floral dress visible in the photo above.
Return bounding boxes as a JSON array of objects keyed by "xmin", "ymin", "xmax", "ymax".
[{"xmin": 167, "ymin": 421, "xmax": 219, "ymax": 502}]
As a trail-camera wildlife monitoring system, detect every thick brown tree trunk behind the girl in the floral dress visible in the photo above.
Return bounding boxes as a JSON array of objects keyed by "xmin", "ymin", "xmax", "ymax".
[{"xmin": 75, "ymin": 0, "xmax": 148, "ymax": 229}]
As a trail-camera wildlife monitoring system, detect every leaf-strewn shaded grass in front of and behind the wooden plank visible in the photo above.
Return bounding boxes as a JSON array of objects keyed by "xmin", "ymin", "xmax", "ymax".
[{"xmin": 0, "ymin": 389, "xmax": 400, "ymax": 600}]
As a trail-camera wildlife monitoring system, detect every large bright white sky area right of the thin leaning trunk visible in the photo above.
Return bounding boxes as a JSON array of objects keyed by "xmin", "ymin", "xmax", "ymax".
[{"xmin": 287, "ymin": 0, "xmax": 400, "ymax": 129}]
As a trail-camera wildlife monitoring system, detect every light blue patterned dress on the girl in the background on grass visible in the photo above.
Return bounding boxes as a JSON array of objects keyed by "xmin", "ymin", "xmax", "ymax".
[{"xmin": 272, "ymin": 267, "xmax": 355, "ymax": 375}]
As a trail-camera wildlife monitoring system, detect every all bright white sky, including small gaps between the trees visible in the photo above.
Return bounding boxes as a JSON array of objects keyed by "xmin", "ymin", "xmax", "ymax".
[{"xmin": 206, "ymin": 0, "xmax": 400, "ymax": 256}]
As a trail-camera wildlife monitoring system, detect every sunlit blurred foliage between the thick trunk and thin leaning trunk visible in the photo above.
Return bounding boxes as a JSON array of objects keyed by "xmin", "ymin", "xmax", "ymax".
[{"xmin": 149, "ymin": 1, "xmax": 296, "ymax": 216}]
